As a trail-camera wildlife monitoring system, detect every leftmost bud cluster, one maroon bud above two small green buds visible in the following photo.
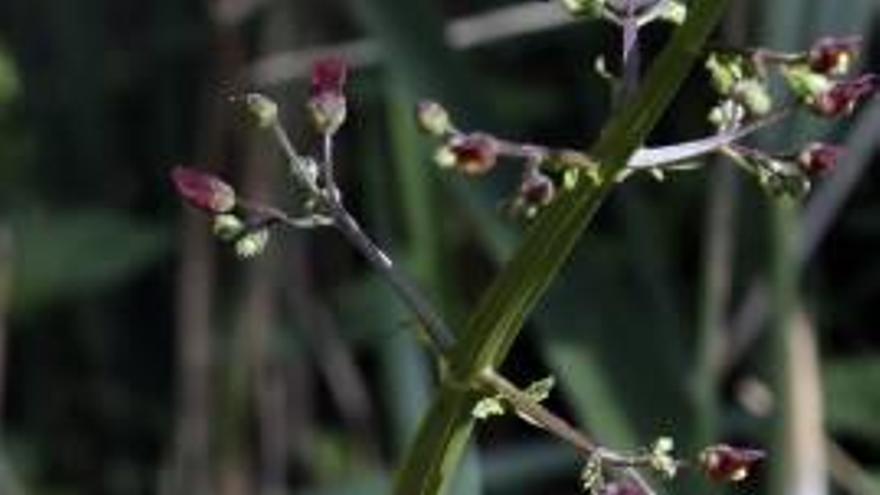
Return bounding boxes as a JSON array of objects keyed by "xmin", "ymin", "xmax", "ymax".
[{"xmin": 171, "ymin": 167, "xmax": 269, "ymax": 258}]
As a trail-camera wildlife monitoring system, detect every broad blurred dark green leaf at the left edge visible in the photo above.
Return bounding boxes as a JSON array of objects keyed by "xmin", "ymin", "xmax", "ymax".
[{"xmin": 11, "ymin": 210, "xmax": 168, "ymax": 311}]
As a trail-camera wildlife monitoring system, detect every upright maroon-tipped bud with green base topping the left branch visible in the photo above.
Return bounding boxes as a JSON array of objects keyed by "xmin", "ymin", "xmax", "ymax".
[{"xmin": 307, "ymin": 58, "xmax": 348, "ymax": 134}]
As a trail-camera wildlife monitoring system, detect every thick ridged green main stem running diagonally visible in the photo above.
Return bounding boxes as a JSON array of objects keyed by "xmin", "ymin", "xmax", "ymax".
[{"xmin": 395, "ymin": 0, "xmax": 727, "ymax": 495}]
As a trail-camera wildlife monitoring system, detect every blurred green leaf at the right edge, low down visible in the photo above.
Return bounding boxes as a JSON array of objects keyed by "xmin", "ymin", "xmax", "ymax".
[{"xmin": 824, "ymin": 357, "xmax": 880, "ymax": 442}]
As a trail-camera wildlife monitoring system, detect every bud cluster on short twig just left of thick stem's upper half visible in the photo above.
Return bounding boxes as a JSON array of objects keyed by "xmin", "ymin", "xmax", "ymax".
[{"xmin": 416, "ymin": 101, "xmax": 568, "ymax": 218}]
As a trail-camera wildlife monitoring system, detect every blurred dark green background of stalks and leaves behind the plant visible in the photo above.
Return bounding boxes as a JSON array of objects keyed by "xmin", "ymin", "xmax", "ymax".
[{"xmin": 0, "ymin": 0, "xmax": 880, "ymax": 495}]
